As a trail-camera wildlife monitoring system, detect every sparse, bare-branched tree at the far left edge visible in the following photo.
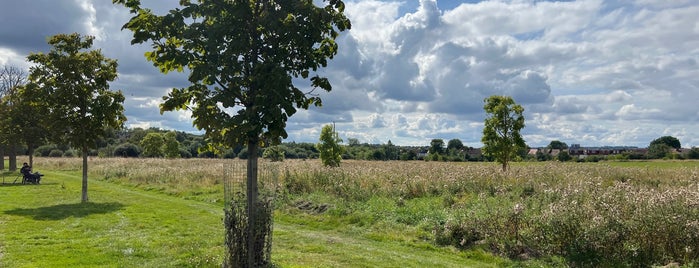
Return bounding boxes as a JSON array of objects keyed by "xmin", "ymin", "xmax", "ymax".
[{"xmin": 0, "ymin": 66, "xmax": 27, "ymax": 171}]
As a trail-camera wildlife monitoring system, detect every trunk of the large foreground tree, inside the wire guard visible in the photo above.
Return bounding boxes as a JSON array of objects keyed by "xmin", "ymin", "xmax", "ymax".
[{"xmin": 247, "ymin": 139, "xmax": 263, "ymax": 265}]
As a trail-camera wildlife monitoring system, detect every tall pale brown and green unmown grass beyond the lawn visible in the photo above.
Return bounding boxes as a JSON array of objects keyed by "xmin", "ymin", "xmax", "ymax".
[{"xmin": 26, "ymin": 158, "xmax": 699, "ymax": 267}]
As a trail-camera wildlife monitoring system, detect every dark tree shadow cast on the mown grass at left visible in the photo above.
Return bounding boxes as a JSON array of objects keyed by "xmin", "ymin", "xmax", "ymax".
[{"xmin": 5, "ymin": 202, "xmax": 124, "ymax": 221}]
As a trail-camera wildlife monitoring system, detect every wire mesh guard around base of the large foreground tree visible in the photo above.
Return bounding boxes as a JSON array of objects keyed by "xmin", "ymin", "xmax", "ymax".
[{"xmin": 223, "ymin": 161, "xmax": 279, "ymax": 267}]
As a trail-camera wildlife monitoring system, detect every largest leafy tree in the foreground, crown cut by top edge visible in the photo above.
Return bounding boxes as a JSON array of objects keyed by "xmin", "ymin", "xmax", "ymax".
[{"xmin": 113, "ymin": 0, "xmax": 350, "ymax": 266}]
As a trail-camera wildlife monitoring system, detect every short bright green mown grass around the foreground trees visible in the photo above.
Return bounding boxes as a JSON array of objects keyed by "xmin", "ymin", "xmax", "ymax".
[{"xmin": 0, "ymin": 170, "xmax": 497, "ymax": 267}]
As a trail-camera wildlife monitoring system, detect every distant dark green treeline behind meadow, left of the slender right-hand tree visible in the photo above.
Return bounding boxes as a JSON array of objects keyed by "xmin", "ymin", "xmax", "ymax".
[{"xmin": 9, "ymin": 128, "xmax": 482, "ymax": 161}]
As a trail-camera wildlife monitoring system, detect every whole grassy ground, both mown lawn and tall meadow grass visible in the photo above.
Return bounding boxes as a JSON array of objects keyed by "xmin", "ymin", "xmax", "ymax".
[{"xmin": 0, "ymin": 158, "xmax": 699, "ymax": 267}]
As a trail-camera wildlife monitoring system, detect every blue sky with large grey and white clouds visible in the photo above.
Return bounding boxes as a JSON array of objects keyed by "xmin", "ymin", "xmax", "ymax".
[{"xmin": 0, "ymin": 0, "xmax": 699, "ymax": 147}]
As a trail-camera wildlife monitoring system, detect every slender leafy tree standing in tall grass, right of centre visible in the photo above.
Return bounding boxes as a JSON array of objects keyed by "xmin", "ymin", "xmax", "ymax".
[{"xmin": 481, "ymin": 96, "xmax": 526, "ymax": 171}]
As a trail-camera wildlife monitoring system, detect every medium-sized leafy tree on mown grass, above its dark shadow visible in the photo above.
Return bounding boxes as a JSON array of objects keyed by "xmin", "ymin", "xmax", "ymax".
[{"xmin": 27, "ymin": 33, "xmax": 126, "ymax": 202}]
